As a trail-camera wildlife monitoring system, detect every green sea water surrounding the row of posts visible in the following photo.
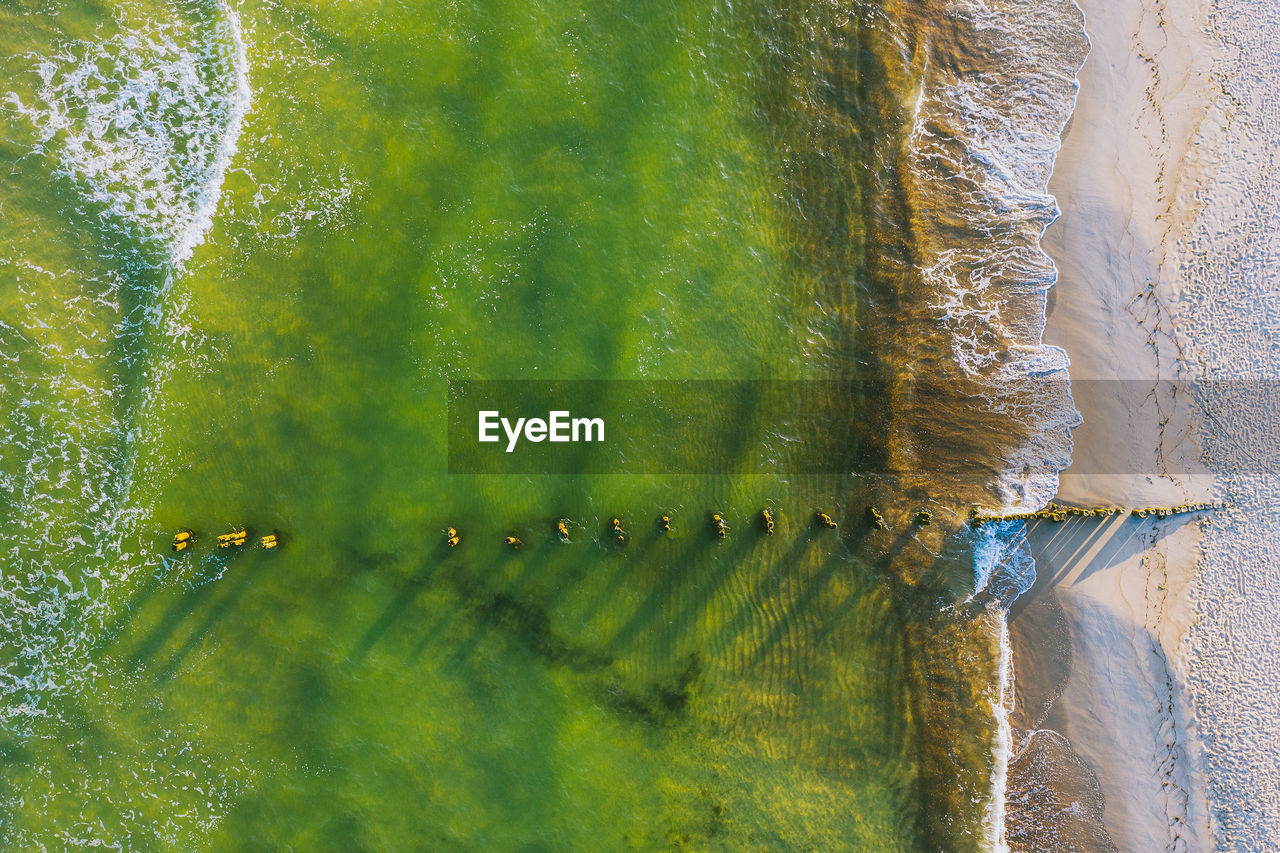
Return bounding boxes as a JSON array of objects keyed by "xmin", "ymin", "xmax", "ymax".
[{"xmin": 0, "ymin": 0, "xmax": 1018, "ymax": 852}]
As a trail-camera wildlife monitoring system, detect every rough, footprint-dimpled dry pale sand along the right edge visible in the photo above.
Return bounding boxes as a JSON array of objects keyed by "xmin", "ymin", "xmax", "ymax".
[{"xmin": 1176, "ymin": 0, "xmax": 1280, "ymax": 835}]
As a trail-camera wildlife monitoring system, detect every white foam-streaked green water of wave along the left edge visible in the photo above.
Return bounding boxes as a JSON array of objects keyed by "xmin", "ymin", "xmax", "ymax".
[{"xmin": 0, "ymin": 3, "xmax": 251, "ymax": 835}]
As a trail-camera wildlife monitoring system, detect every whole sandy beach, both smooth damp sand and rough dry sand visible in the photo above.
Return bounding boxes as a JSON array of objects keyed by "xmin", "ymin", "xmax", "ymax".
[{"xmin": 1009, "ymin": 0, "xmax": 1280, "ymax": 850}]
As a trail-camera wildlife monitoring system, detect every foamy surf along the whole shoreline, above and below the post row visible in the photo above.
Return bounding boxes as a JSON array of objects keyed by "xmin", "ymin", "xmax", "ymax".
[{"xmin": 880, "ymin": 0, "xmax": 1089, "ymax": 850}]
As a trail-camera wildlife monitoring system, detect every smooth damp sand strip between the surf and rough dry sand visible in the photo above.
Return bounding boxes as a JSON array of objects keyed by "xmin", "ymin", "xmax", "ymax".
[{"xmin": 1007, "ymin": 0, "xmax": 1215, "ymax": 849}]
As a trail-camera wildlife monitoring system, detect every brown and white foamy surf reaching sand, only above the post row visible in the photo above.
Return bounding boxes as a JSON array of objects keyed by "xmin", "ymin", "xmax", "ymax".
[{"xmin": 904, "ymin": 0, "xmax": 1088, "ymax": 511}]
